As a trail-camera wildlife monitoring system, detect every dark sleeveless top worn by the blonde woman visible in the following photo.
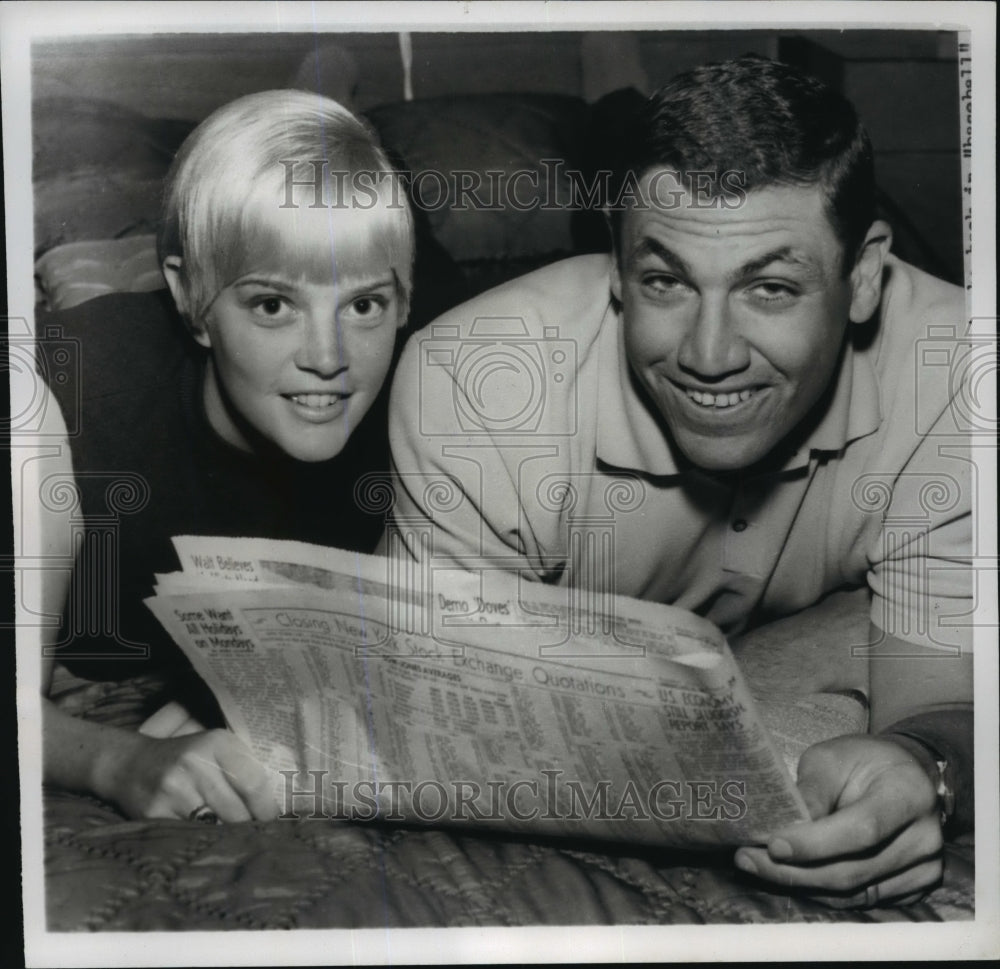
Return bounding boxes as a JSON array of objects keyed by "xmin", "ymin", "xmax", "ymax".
[{"xmin": 44, "ymin": 290, "xmax": 389, "ymax": 680}]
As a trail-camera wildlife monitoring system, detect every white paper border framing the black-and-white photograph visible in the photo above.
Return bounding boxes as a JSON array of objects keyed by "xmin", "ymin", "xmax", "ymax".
[{"xmin": 0, "ymin": 0, "xmax": 1000, "ymax": 966}]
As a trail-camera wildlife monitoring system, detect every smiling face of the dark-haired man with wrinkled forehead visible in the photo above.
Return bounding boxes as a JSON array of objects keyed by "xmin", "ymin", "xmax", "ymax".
[{"xmin": 613, "ymin": 172, "xmax": 853, "ymax": 471}]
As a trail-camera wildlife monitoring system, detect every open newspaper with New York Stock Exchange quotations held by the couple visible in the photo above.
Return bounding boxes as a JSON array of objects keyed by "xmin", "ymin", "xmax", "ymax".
[{"xmin": 147, "ymin": 537, "xmax": 820, "ymax": 847}]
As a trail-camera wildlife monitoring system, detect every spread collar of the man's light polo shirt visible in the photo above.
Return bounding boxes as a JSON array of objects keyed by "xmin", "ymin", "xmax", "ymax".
[{"xmin": 597, "ymin": 303, "xmax": 882, "ymax": 476}]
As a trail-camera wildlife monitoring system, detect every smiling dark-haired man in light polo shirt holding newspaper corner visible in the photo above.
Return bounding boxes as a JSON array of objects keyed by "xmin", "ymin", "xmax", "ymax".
[{"xmin": 390, "ymin": 57, "xmax": 972, "ymax": 905}]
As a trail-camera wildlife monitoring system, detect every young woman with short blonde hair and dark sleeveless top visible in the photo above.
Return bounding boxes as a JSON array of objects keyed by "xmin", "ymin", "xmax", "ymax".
[{"xmin": 39, "ymin": 91, "xmax": 414, "ymax": 821}]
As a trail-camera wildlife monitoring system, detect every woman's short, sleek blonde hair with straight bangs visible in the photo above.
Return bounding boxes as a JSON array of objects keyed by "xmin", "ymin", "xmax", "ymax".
[{"xmin": 157, "ymin": 90, "xmax": 414, "ymax": 321}]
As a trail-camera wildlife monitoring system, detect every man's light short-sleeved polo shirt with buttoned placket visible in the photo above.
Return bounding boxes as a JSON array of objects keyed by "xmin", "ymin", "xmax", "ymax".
[{"xmin": 390, "ymin": 255, "xmax": 972, "ymax": 645}]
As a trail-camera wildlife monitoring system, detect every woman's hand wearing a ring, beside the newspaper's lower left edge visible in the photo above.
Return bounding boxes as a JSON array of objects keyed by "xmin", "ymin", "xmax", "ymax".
[{"xmin": 93, "ymin": 730, "xmax": 278, "ymax": 821}]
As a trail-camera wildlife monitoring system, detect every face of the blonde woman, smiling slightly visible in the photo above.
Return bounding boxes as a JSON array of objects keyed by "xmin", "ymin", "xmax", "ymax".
[{"xmin": 184, "ymin": 200, "xmax": 404, "ymax": 461}]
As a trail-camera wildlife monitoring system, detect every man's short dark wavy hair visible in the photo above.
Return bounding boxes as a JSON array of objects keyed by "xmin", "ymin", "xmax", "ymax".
[{"xmin": 611, "ymin": 54, "xmax": 875, "ymax": 275}]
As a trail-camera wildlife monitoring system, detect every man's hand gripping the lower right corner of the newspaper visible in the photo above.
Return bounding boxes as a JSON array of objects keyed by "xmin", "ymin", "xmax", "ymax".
[{"xmin": 735, "ymin": 734, "xmax": 944, "ymax": 908}]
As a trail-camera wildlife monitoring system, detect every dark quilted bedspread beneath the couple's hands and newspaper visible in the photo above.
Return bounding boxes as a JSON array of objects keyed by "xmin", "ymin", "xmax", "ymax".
[{"xmin": 45, "ymin": 664, "xmax": 974, "ymax": 931}]
